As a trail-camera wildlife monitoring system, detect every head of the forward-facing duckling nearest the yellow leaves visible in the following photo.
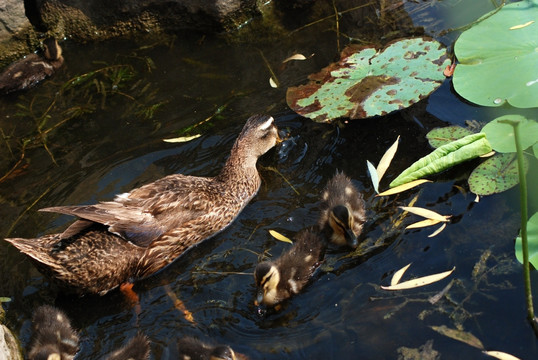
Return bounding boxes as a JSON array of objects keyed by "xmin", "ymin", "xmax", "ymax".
[{"xmin": 328, "ymin": 205, "xmax": 362, "ymax": 249}]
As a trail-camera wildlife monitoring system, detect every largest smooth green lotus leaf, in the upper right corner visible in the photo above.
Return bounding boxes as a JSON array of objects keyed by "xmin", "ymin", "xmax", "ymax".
[{"xmin": 452, "ymin": 0, "xmax": 538, "ymax": 108}]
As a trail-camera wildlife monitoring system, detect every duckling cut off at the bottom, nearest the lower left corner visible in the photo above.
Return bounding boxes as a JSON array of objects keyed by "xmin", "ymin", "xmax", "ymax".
[{"xmin": 28, "ymin": 305, "xmax": 79, "ymax": 360}]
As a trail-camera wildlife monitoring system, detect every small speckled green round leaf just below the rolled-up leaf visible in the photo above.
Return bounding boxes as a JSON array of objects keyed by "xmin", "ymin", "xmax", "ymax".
[{"xmin": 468, "ymin": 153, "xmax": 529, "ymax": 195}]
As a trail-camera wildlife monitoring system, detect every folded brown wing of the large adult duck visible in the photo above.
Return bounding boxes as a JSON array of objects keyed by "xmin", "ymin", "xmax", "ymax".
[{"xmin": 40, "ymin": 174, "xmax": 218, "ymax": 247}]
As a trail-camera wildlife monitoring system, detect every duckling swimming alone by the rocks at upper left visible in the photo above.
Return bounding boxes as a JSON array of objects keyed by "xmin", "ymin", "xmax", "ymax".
[{"xmin": 0, "ymin": 37, "xmax": 64, "ymax": 94}]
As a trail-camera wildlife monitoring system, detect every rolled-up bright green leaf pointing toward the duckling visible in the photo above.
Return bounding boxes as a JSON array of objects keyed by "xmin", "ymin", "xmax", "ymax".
[{"xmin": 389, "ymin": 133, "xmax": 491, "ymax": 188}]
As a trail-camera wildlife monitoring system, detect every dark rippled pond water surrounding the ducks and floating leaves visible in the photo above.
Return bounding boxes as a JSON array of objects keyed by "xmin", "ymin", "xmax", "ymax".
[{"xmin": 0, "ymin": 1, "xmax": 538, "ymax": 359}]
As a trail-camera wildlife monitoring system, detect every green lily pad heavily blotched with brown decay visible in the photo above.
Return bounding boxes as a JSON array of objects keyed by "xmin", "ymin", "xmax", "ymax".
[{"xmin": 286, "ymin": 37, "xmax": 450, "ymax": 122}]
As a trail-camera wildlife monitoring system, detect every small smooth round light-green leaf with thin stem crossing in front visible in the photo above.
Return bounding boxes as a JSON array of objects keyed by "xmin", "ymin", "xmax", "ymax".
[{"xmin": 482, "ymin": 114, "xmax": 538, "ymax": 152}]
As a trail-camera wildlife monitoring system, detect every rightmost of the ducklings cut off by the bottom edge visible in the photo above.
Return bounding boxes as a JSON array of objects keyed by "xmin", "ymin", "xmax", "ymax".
[{"xmin": 177, "ymin": 337, "xmax": 236, "ymax": 360}]
